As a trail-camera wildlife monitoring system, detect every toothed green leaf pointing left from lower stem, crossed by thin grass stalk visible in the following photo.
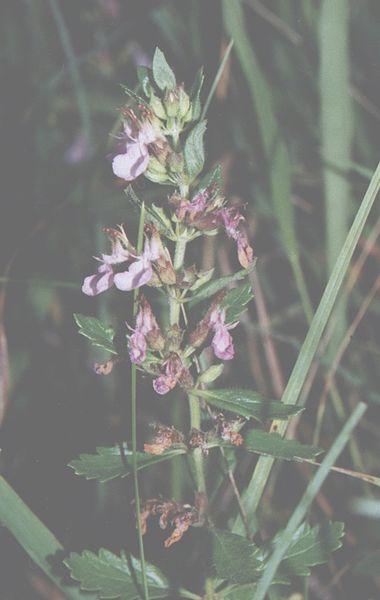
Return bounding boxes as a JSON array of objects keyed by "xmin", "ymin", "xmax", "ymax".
[{"xmin": 68, "ymin": 446, "xmax": 185, "ymax": 482}]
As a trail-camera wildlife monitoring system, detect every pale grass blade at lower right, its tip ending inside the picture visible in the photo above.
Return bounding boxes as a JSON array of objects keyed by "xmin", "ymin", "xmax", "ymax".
[{"xmin": 253, "ymin": 402, "xmax": 367, "ymax": 600}]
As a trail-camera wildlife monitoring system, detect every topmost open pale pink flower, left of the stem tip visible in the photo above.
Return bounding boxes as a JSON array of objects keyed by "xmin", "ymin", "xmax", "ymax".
[{"xmin": 112, "ymin": 109, "xmax": 162, "ymax": 181}]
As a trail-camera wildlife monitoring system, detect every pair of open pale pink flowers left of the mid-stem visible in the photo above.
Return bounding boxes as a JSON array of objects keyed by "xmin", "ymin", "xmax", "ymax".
[{"xmin": 82, "ymin": 227, "xmax": 158, "ymax": 296}]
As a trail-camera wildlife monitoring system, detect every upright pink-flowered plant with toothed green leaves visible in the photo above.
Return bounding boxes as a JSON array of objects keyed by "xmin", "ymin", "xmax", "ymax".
[{"xmin": 66, "ymin": 49, "xmax": 342, "ymax": 600}]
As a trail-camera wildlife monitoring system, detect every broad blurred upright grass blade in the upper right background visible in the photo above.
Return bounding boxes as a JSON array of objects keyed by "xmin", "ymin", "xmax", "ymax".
[{"xmin": 319, "ymin": 0, "xmax": 353, "ymax": 350}]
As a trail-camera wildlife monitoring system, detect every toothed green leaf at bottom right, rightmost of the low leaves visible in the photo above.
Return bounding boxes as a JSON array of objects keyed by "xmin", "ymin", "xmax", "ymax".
[{"xmin": 270, "ymin": 521, "xmax": 344, "ymax": 577}]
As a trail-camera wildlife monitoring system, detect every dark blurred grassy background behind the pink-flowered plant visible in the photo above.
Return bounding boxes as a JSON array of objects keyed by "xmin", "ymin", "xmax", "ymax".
[{"xmin": 0, "ymin": 0, "xmax": 380, "ymax": 600}]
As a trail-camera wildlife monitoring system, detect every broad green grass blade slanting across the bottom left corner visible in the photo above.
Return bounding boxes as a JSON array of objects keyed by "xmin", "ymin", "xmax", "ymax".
[{"xmin": 0, "ymin": 477, "xmax": 97, "ymax": 600}]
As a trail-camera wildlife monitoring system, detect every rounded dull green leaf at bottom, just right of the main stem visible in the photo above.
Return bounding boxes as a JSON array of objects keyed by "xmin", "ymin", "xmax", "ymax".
[{"xmin": 212, "ymin": 530, "xmax": 264, "ymax": 583}]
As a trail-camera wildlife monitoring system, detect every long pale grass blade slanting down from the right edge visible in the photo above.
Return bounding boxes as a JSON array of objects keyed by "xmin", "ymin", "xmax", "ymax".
[{"xmin": 233, "ymin": 163, "xmax": 380, "ymax": 532}]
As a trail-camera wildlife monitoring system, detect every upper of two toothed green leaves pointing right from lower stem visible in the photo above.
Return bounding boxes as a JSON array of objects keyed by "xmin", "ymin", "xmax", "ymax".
[{"xmin": 191, "ymin": 388, "xmax": 302, "ymax": 421}]
